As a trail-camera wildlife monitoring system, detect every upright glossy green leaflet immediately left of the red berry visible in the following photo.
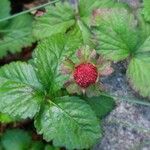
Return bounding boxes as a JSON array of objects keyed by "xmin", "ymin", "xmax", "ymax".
[{"xmin": 34, "ymin": 31, "xmax": 82, "ymax": 94}]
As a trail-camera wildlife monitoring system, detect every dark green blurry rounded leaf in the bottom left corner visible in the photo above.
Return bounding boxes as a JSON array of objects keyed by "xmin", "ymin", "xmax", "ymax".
[{"xmin": 1, "ymin": 129, "xmax": 31, "ymax": 150}]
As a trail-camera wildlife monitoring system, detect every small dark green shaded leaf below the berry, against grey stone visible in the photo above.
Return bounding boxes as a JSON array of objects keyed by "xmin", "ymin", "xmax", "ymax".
[{"xmin": 86, "ymin": 95, "xmax": 115, "ymax": 119}]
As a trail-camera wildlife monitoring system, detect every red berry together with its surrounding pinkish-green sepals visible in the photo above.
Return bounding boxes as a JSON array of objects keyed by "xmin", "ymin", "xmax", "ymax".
[{"xmin": 61, "ymin": 46, "xmax": 113, "ymax": 94}]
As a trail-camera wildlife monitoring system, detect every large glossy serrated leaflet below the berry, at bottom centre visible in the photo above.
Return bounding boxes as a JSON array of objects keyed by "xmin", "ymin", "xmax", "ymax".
[{"xmin": 35, "ymin": 96, "xmax": 101, "ymax": 149}]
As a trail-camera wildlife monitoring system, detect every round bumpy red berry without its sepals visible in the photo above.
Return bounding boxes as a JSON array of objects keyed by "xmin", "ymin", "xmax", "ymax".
[{"xmin": 73, "ymin": 63, "xmax": 98, "ymax": 88}]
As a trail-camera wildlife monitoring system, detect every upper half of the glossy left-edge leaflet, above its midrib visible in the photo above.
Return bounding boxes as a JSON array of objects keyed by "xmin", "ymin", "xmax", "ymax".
[{"xmin": 0, "ymin": 61, "xmax": 42, "ymax": 89}]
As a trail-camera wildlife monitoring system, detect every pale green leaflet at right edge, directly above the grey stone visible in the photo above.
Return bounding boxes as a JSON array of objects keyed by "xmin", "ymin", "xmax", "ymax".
[{"xmin": 127, "ymin": 53, "xmax": 150, "ymax": 98}]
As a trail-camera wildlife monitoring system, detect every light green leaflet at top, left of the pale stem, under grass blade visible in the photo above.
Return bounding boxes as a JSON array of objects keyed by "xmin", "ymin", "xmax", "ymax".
[{"xmin": 33, "ymin": 2, "xmax": 75, "ymax": 39}]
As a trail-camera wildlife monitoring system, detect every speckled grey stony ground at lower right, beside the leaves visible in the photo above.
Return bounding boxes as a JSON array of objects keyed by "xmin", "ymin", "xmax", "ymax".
[{"xmin": 93, "ymin": 62, "xmax": 150, "ymax": 150}]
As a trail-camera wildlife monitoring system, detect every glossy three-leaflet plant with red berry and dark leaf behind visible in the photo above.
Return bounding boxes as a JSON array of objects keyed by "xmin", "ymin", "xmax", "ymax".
[{"xmin": 0, "ymin": 33, "xmax": 115, "ymax": 149}]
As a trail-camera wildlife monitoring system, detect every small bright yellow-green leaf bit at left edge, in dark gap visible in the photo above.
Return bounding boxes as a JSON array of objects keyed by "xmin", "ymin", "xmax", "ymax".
[{"xmin": 0, "ymin": 113, "xmax": 18, "ymax": 123}]
